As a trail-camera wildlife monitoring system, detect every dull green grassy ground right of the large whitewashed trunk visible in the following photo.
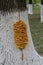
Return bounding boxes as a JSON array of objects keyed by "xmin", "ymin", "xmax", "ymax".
[{"xmin": 29, "ymin": 6, "xmax": 43, "ymax": 56}]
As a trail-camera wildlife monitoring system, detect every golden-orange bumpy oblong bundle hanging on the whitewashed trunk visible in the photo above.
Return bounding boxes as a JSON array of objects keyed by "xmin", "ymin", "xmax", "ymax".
[{"xmin": 13, "ymin": 20, "xmax": 28, "ymax": 49}]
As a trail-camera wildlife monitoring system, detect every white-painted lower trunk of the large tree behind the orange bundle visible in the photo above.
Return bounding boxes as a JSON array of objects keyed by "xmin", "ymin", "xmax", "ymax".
[{"xmin": 0, "ymin": 11, "xmax": 43, "ymax": 65}]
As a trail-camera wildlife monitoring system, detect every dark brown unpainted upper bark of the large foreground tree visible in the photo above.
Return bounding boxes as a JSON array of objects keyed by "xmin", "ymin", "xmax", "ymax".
[{"xmin": 0, "ymin": 0, "xmax": 26, "ymax": 12}]
